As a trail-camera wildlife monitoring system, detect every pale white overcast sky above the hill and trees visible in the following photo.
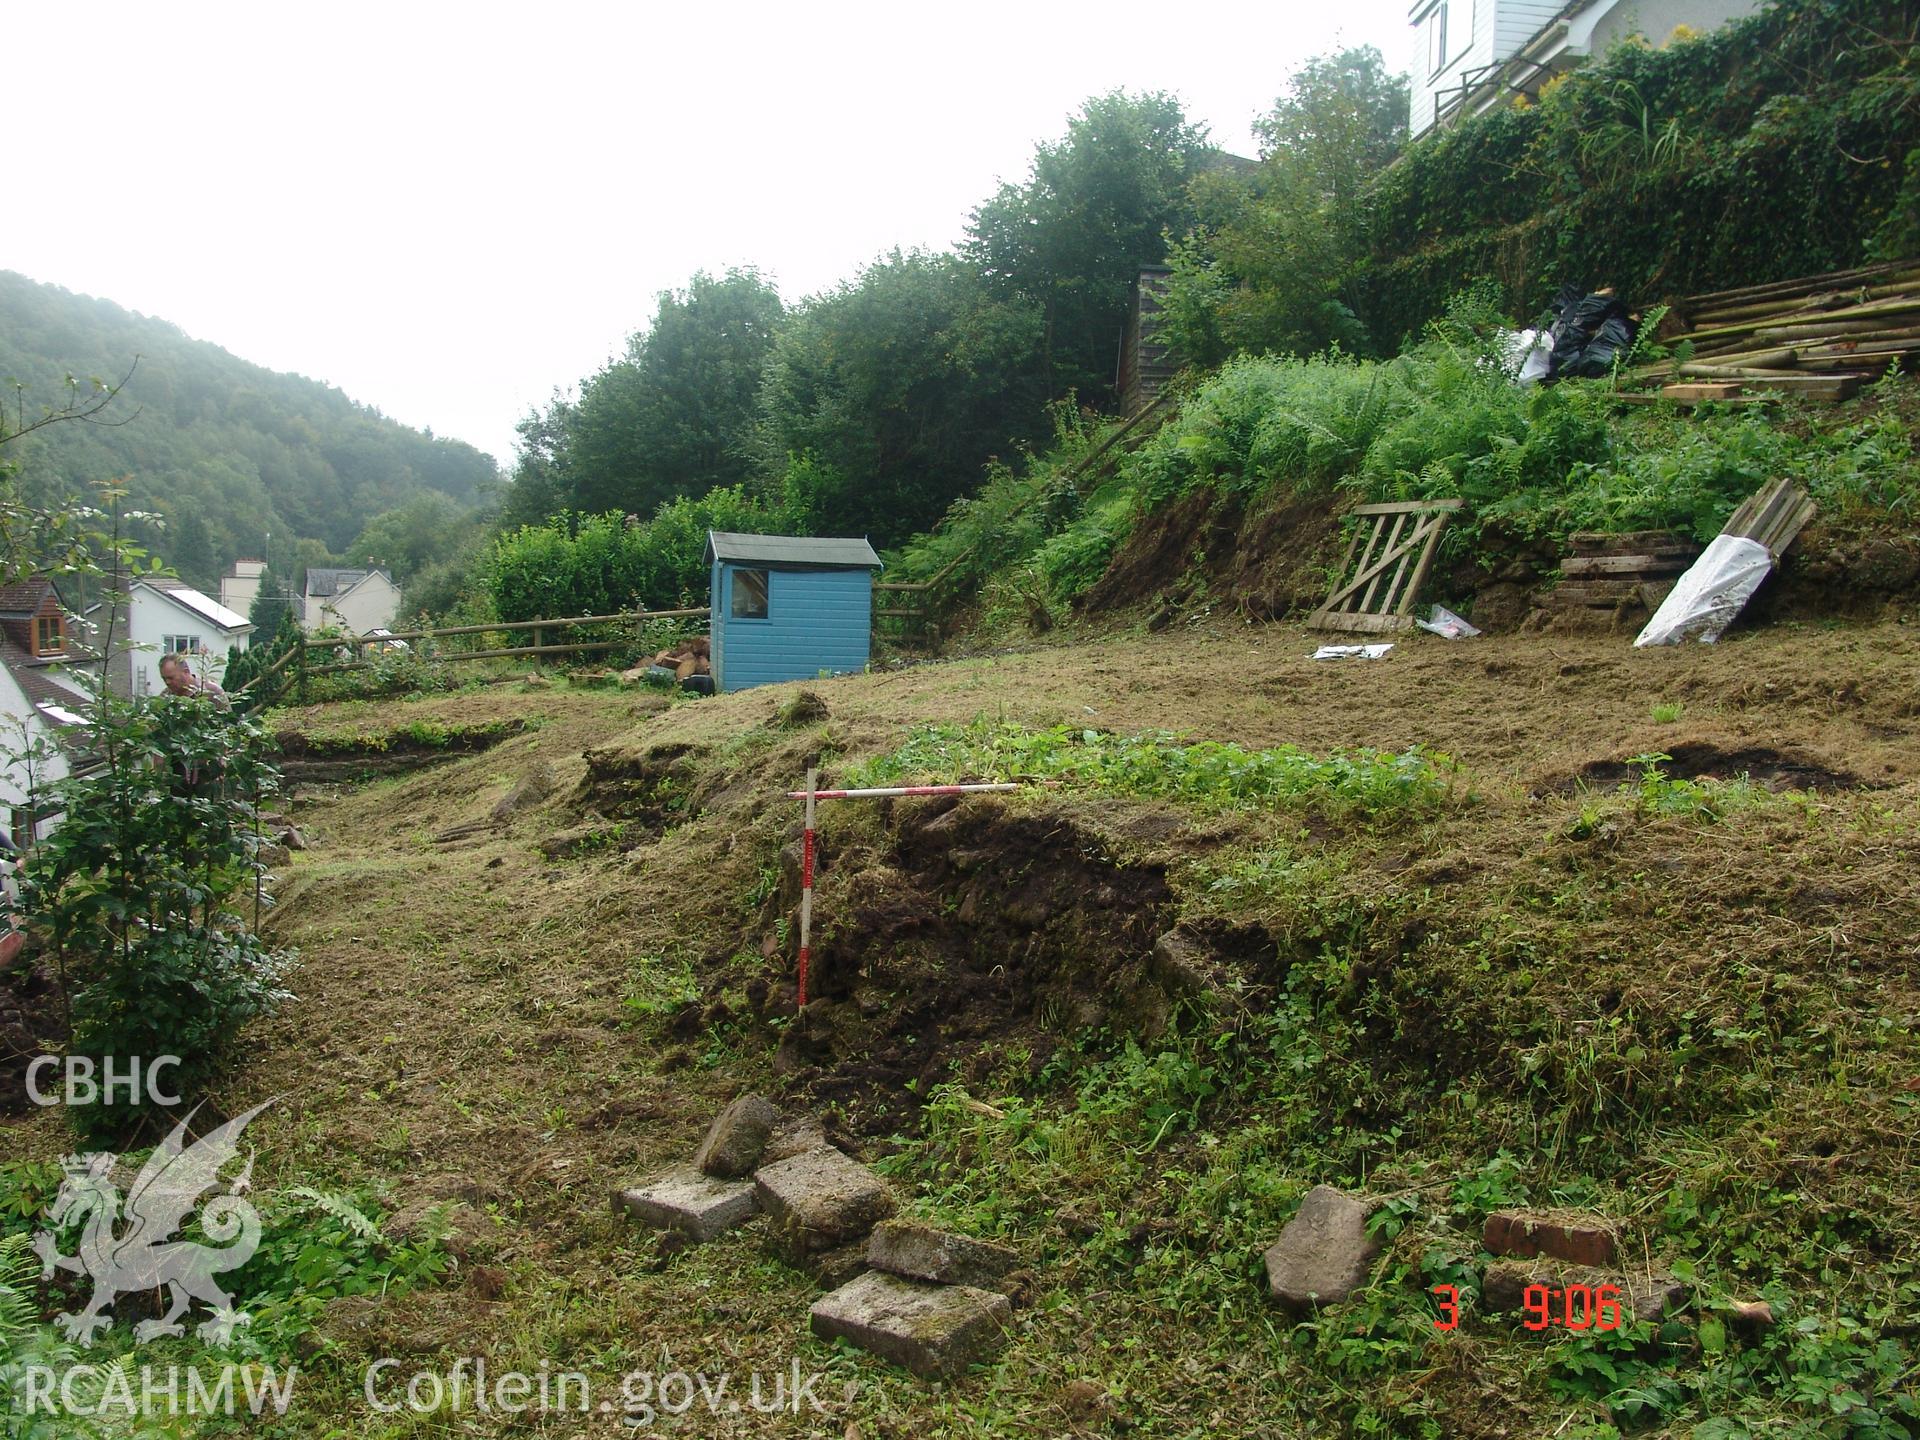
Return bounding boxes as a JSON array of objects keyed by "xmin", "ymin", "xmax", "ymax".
[{"xmin": 11, "ymin": 0, "xmax": 1411, "ymax": 463}]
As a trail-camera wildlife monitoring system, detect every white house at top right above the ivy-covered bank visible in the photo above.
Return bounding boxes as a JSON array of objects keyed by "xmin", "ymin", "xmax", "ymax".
[{"xmin": 1407, "ymin": 0, "xmax": 1766, "ymax": 134}]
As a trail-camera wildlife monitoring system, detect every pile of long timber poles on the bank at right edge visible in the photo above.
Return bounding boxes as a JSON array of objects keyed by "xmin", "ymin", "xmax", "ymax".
[{"xmin": 1634, "ymin": 259, "xmax": 1920, "ymax": 403}]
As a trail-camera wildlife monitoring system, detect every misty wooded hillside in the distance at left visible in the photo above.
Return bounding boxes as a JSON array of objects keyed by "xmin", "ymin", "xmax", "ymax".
[{"xmin": 0, "ymin": 271, "xmax": 499, "ymax": 584}]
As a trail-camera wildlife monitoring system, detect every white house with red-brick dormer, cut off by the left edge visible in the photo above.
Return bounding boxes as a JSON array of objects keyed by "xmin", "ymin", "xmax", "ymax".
[{"xmin": 0, "ymin": 578, "xmax": 86, "ymax": 847}]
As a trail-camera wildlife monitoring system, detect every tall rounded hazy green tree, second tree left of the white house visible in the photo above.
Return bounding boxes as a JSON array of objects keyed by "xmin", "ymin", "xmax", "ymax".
[{"xmin": 962, "ymin": 90, "xmax": 1217, "ymax": 405}]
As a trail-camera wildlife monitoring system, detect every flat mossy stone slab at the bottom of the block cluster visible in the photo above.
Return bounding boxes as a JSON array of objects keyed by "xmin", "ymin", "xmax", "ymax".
[{"xmin": 810, "ymin": 1271, "xmax": 1014, "ymax": 1379}]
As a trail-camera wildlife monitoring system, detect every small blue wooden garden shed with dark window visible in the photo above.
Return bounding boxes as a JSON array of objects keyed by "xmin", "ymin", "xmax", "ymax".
[{"xmin": 707, "ymin": 530, "xmax": 881, "ymax": 691}]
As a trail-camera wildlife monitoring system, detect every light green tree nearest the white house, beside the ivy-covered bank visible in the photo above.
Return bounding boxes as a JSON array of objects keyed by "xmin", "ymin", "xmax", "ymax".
[{"xmin": 1164, "ymin": 46, "xmax": 1407, "ymax": 363}]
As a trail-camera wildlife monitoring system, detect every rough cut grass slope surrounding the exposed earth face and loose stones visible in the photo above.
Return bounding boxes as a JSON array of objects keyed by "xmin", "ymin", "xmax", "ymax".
[{"xmin": 0, "ymin": 624, "xmax": 1920, "ymax": 1440}]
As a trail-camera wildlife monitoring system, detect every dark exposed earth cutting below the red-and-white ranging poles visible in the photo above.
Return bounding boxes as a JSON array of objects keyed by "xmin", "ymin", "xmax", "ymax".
[{"xmin": 749, "ymin": 799, "xmax": 1284, "ymax": 1135}]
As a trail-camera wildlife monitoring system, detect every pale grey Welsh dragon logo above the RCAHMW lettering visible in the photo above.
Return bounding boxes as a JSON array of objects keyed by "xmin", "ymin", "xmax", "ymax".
[{"xmin": 33, "ymin": 1100, "xmax": 273, "ymax": 1346}]
